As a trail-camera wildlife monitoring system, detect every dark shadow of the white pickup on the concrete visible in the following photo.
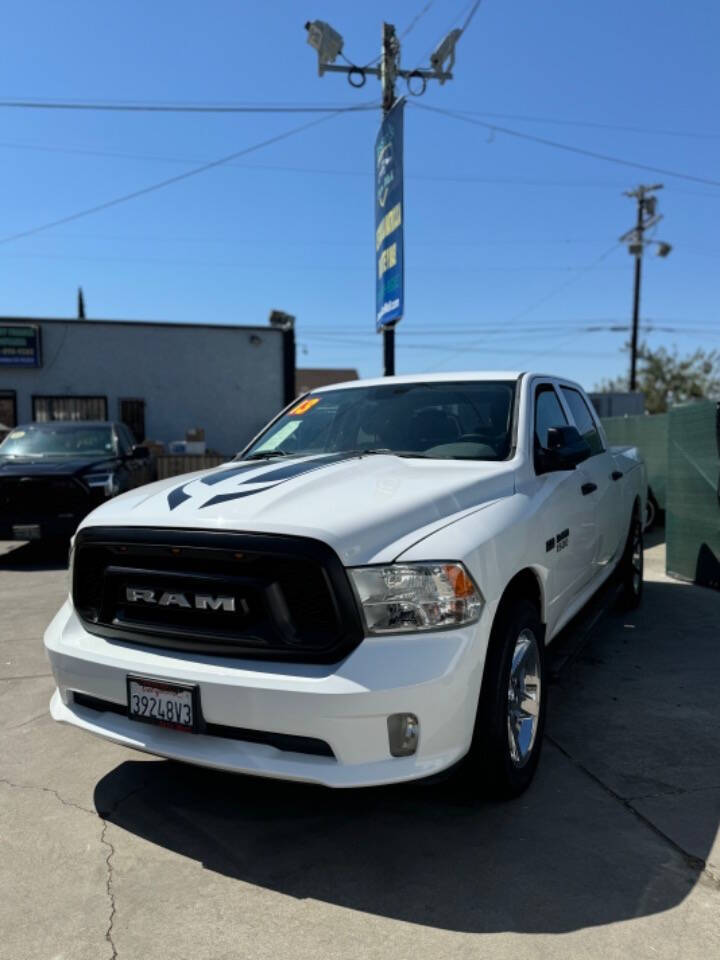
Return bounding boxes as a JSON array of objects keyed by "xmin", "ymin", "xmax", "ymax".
[{"xmin": 95, "ymin": 583, "xmax": 720, "ymax": 933}]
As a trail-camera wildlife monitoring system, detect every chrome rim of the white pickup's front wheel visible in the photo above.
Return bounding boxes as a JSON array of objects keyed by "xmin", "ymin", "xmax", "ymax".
[{"xmin": 507, "ymin": 627, "xmax": 542, "ymax": 767}]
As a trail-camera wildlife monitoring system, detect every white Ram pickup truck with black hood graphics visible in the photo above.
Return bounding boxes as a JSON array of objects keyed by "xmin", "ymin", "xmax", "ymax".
[{"xmin": 45, "ymin": 373, "xmax": 646, "ymax": 797}]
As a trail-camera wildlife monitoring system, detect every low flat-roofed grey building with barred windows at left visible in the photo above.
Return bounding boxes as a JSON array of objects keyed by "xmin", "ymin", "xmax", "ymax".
[{"xmin": 0, "ymin": 318, "xmax": 294, "ymax": 454}]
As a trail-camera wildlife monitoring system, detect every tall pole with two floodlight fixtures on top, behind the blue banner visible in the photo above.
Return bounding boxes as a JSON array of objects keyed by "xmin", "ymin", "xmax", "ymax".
[{"xmin": 305, "ymin": 18, "xmax": 462, "ymax": 377}]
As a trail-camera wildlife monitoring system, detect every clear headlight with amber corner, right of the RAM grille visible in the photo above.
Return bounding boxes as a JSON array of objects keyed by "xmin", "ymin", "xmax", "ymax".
[{"xmin": 348, "ymin": 562, "xmax": 483, "ymax": 633}]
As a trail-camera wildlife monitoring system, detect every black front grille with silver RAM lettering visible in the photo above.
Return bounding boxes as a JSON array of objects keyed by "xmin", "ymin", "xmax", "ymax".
[{"xmin": 73, "ymin": 527, "xmax": 363, "ymax": 663}]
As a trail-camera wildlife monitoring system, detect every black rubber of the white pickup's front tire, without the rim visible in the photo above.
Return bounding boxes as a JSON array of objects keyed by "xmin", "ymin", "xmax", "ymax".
[{"xmin": 460, "ymin": 598, "xmax": 547, "ymax": 800}]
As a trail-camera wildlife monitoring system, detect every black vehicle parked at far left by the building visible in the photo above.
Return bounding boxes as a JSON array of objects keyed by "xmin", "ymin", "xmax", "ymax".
[{"xmin": 0, "ymin": 421, "xmax": 157, "ymax": 540}]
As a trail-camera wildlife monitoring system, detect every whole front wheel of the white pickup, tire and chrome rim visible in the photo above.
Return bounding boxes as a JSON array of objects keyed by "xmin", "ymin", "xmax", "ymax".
[{"xmin": 464, "ymin": 600, "xmax": 547, "ymax": 799}]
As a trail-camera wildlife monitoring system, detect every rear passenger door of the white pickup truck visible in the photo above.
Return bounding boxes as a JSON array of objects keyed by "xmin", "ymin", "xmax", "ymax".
[{"xmin": 560, "ymin": 386, "xmax": 625, "ymax": 574}]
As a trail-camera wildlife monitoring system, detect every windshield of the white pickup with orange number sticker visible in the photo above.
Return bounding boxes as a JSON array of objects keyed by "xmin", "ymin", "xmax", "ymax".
[{"xmin": 243, "ymin": 380, "xmax": 515, "ymax": 460}]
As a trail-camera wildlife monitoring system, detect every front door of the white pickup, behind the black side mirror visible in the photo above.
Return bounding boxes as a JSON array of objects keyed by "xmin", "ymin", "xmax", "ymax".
[{"xmin": 534, "ymin": 383, "xmax": 597, "ymax": 610}]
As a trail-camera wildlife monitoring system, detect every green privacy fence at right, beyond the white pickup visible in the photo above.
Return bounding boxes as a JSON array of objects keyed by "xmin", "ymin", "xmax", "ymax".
[{"xmin": 603, "ymin": 400, "xmax": 720, "ymax": 588}]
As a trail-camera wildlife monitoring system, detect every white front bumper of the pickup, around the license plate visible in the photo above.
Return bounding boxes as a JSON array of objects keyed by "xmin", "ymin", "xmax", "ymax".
[{"xmin": 45, "ymin": 601, "xmax": 490, "ymax": 787}]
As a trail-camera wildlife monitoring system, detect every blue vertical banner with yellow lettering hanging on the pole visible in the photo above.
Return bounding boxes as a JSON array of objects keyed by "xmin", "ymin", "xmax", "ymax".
[{"xmin": 375, "ymin": 99, "xmax": 405, "ymax": 333}]
